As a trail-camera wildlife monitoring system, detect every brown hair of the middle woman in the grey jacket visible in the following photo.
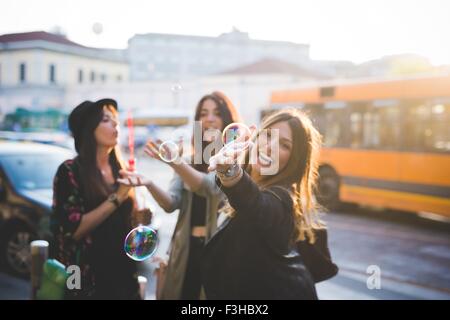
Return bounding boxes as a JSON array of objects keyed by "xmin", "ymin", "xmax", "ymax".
[{"xmin": 191, "ymin": 91, "xmax": 241, "ymax": 172}]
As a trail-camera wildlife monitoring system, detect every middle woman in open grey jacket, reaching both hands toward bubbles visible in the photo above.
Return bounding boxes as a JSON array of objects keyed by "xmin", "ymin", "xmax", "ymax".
[{"xmin": 120, "ymin": 92, "xmax": 239, "ymax": 300}]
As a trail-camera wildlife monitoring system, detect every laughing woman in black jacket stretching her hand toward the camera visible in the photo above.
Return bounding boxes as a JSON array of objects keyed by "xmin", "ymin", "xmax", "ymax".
[{"xmin": 203, "ymin": 109, "xmax": 321, "ymax": 299}]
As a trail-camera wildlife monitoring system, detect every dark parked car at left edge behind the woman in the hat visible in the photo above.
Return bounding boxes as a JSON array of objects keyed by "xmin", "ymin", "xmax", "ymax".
[{"xmin": 0, "ymin": 141, "xmax": 74, "ymax": 276}]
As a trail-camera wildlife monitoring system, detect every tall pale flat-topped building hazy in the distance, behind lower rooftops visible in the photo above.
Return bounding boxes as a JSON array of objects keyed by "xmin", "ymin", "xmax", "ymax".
[{"xmin": 128, "ymin": 29, "xmax": 311, "ymax": 81}]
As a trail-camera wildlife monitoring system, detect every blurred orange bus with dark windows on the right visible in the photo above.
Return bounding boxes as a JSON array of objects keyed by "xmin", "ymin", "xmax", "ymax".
[{"xmin": 265, "ymin": 76, "xmax": 450, "ymax": 218}]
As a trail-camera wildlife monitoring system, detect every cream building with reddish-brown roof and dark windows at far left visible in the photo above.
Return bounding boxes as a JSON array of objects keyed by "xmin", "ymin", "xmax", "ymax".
[{"xmin": 0, "ymin": 32, "xmax": 129, "ymax": 114}]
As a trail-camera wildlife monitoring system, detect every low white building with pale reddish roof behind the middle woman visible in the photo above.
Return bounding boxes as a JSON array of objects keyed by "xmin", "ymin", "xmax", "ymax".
[{"xmin": 65, "ymin": 60, "xmax": 324, "ymax": 124}]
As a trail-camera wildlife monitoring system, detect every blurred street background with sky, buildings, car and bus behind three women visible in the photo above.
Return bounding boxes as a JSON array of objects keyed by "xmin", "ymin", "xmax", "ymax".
[{"xmin": 0, "ymin": 0, "xmax": 450, "ymax": 299}]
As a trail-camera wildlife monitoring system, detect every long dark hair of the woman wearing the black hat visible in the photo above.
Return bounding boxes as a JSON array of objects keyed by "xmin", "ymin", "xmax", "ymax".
[{"xmin": 78, "ymin": 106, "xmax": 125, "ymax": 208}]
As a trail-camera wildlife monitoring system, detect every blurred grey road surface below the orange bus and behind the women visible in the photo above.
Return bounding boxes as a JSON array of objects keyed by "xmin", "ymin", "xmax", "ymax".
[{"xmin": 0, "ymin": 159, "xmax": 450, "ymax": 299}]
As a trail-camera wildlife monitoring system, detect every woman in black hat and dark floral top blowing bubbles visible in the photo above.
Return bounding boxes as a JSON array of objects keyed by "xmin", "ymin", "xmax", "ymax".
[{"xmin": 51, "ymin": 99, "xmax": 139, "ymax": 299}]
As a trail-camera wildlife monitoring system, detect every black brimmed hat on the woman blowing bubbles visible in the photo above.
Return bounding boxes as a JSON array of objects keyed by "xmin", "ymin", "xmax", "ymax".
[{"xmin": 68, "ymin": 98, "xmax": 118, "ymax": 151}]
